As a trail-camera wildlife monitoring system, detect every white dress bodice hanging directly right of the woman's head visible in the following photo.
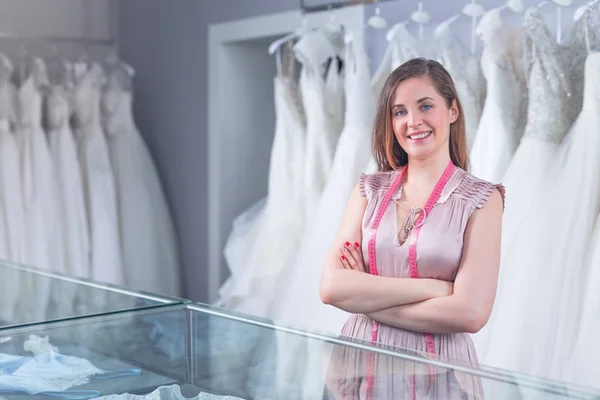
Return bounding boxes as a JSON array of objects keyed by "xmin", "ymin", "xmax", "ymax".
[{"xmin": 434, "ymin": 20, "xmax": 481, "ymax": 149}]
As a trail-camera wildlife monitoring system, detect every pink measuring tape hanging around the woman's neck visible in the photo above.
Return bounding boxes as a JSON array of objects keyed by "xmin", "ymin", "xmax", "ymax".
[{"xmin": 367, "ymin": 161, "xmax": 455, "ymax": 399}]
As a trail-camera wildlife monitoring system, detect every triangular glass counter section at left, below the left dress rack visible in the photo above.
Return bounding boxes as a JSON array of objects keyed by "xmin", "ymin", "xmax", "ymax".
[{"xmin": 0, "ymin": 262, "xmax": 183, "ymax": 329}]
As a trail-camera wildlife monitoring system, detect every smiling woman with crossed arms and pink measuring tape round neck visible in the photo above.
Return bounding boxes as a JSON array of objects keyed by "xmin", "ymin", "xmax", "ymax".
[{"xmin": 320, "ymin": 59, "xmax": 504, "ymax": 399}]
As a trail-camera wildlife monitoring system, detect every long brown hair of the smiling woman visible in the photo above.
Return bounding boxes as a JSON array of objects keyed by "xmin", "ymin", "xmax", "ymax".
[{"xmin": 373, "ymin": 58, "xmax": 469, "ymax": 171}]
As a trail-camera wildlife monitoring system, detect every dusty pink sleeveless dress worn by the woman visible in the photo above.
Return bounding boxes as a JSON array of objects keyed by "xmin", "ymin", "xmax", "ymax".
[{"xmin": 328, "ymin": 165, "xmax": 504, "ymax": 399}]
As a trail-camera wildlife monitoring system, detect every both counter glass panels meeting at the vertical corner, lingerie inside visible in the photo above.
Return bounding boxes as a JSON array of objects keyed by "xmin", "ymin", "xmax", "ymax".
[{"xmin": 0, "ymin": 304, "xmax": 600, "ymax": 400}]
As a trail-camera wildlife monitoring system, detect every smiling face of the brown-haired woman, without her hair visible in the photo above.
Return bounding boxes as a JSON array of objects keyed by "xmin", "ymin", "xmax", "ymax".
[{"xmin": 391, "ymin": 78, "xmax": 458, "ymax": 160}]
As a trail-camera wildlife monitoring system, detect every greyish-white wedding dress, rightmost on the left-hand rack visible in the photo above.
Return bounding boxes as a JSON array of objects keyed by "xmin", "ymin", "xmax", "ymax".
[{"xmin": 102, "ymin": 68, "xmax": 181, "ymax": 296}]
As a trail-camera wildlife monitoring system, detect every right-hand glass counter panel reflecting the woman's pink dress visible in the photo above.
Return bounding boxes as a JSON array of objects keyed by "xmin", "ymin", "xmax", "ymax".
[{"xmin": 189, "ymin": 304, "xmax": 600, "ymax": 399}]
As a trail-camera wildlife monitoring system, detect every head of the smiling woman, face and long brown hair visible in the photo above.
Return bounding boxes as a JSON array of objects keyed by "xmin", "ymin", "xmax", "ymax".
[{"xmin": 373, "ymin": 59, "xmax": 469, "ymax": 171}]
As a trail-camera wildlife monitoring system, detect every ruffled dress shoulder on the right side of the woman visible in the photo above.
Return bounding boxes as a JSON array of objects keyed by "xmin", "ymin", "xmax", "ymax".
[{"xmin": 439, "ymin": 168, "xmax": 505, "ymax": 208}]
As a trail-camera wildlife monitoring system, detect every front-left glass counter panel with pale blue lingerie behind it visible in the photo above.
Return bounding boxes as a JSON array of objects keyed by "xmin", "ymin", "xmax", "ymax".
[{"xmin": 0, "ymin": 305, "xmax": 187, "ymax": 400}]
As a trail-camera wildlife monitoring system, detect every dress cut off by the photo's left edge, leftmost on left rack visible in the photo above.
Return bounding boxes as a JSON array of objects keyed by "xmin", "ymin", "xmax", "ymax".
[{"xmin": 0, "ymin": 54, "xmax": 25, "ymax": 320}]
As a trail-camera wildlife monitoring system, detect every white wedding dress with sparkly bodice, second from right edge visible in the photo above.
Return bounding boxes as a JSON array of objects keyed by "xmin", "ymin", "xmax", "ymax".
[{"xmin": 474, "ymin": 9, "xmax": 585, "ymax": 377}]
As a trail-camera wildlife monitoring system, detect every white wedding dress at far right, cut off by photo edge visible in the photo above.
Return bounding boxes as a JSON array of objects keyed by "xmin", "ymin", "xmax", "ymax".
[{"xmin": 536, "ymin": 53, "xmax": 600, "ymax": 388}]
